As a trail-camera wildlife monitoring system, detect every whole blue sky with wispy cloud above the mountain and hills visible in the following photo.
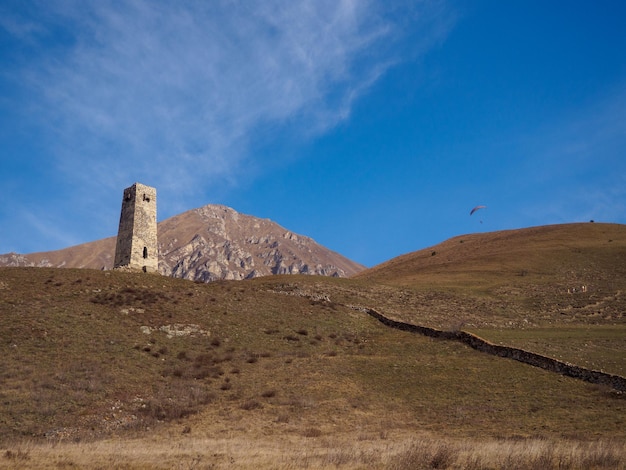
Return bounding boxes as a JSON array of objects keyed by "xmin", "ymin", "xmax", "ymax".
[{"xmin": 0, "ymin": 0, "xmax": 626, "ymax": 266}]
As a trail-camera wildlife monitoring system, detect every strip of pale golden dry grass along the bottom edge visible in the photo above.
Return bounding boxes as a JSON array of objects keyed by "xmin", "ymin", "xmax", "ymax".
[{"xmin": 0, "ymin": 432, "xmax": 626, "ymax": 470}]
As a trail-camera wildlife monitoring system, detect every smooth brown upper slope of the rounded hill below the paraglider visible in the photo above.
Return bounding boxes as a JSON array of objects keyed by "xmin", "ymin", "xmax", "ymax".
[{"xmin": 356, "ymin": 223, "xmax": 626, "ymax": 287}]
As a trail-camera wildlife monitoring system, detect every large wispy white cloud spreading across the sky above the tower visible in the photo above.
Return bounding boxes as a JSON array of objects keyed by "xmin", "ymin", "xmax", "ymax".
[{"xmin": 0, "ymin": 0, "xmax": 449, "ymax": 253}]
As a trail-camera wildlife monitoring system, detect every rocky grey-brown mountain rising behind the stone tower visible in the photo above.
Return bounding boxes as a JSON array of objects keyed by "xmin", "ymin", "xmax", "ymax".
[{"xmin": 0, "ymin": 204, "xmax": 364, "ymax": 282}]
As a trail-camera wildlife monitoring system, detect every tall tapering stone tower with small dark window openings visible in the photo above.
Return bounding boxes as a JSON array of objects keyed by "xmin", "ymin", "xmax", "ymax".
[{"xmin": 113, "ymin": 183, "xmax": 159, "ymax": 272}]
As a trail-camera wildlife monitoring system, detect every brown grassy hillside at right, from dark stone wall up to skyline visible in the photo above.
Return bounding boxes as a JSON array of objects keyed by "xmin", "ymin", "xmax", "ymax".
[{"xmin": 356, "ymin": 223, "xmax": 626, "ymax": 375}]
